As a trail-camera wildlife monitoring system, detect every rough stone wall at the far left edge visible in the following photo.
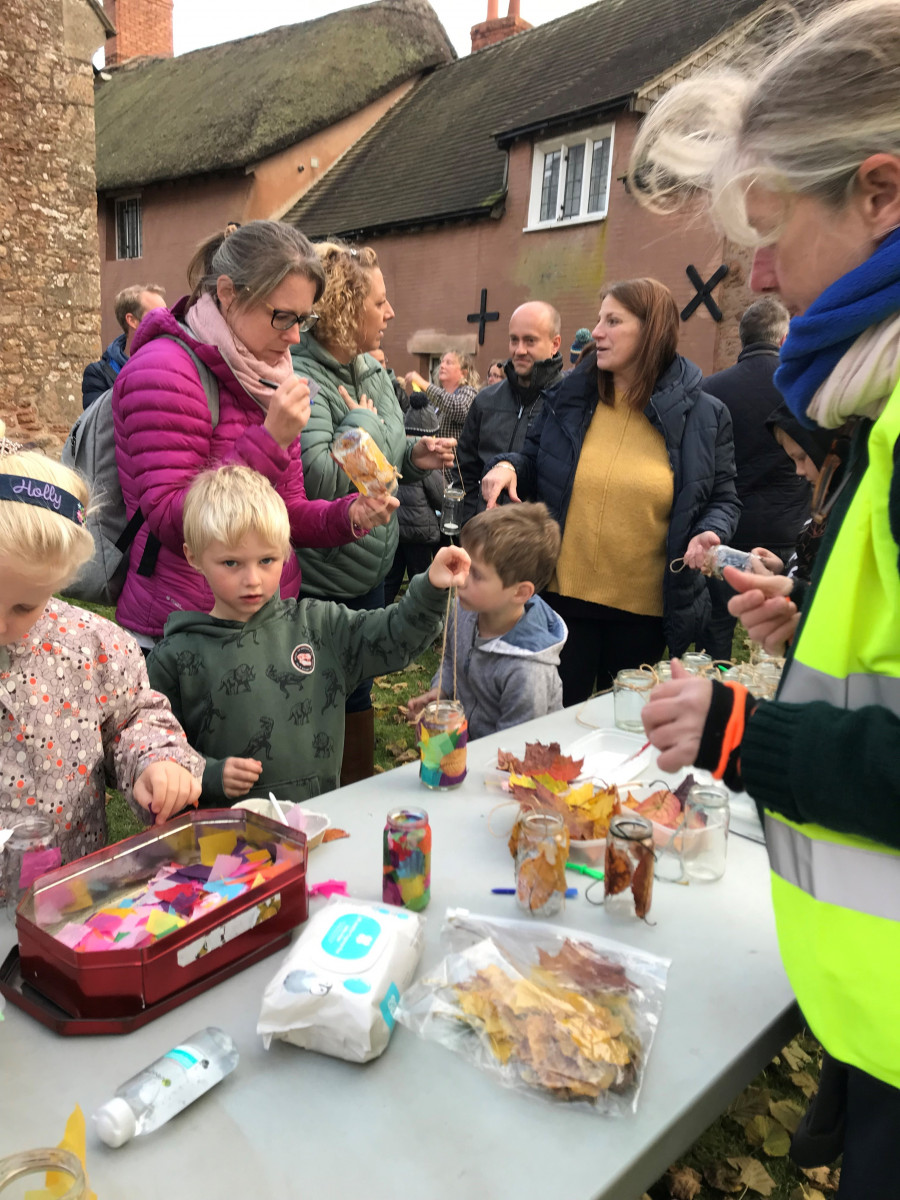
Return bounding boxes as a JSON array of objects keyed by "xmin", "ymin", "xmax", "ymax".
[{"xmin": 0, "ymin": 0, "xmax": 106, "ymax": 446}]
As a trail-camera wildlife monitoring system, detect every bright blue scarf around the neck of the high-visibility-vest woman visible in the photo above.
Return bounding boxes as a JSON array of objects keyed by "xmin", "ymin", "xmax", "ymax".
[{"xmin": 775, "ymin": 229, "xmax": 900, "ymax": 430}]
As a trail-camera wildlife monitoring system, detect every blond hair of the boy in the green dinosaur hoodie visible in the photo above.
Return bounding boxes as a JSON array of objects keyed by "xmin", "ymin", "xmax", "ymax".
[{"xmin": 184, "ymin": 464, "xmax": 290, "ymax": 558}]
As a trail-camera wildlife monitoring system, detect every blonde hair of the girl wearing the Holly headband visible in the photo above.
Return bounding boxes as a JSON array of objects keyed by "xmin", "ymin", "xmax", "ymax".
[{"xmin": 0, "ymin": 450, "xmax": 94, "ymax": 582}]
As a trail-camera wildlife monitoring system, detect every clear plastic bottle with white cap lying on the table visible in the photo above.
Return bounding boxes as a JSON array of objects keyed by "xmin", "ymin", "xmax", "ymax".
[{"xmin": 91, "ymin": 1026, "xmax": 239, "ymax": 1147}]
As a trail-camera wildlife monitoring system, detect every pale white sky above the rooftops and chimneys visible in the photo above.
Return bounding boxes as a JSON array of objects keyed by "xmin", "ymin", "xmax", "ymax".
[{"xmin": 174, "ymin": 0, "xmax": 595, "ymax": 55}]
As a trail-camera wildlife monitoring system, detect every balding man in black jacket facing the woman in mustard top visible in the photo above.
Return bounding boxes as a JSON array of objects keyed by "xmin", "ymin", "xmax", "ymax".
[{"xmin": 456, "ymin": 300, "xmax": 563, "ymax": 522}]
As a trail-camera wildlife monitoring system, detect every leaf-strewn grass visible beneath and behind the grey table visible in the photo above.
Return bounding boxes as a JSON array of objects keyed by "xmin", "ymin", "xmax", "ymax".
[{"xmin": 98, "ymin": 605, "xmax": 836, "ymax": 1200}]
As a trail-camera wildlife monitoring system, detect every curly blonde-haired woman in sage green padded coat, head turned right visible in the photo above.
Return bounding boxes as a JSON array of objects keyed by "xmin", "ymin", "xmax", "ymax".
[{"xmin": 290, "ymin": 242, "xmax": 456, "ymax": 785}]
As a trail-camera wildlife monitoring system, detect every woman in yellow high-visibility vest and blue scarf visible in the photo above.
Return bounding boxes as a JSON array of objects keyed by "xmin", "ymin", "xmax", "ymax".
[{"xmin": 631, "ymin": 0, "xmax": 900, "ymax": 1200}]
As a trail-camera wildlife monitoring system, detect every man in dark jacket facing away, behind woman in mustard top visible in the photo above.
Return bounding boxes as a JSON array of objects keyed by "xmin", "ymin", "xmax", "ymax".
[{"xmin": 697, "ymin": 296, "xmax": 810, "ymax": 659}]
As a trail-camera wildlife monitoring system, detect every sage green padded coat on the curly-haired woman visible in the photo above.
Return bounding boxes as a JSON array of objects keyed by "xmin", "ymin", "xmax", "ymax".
[{"xmin": 290, "ymin": 334, "xmax": 427, "ymax": 599}]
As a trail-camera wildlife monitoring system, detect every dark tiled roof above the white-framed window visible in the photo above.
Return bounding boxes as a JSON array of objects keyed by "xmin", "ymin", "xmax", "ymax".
[{"xmin": 284, "ymin": 0, "xmax": 763, "ymax": 236}]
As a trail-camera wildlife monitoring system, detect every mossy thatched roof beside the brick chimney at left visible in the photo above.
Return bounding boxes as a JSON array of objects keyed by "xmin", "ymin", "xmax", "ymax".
[{"xmin": 95, "ymin": 0, "xmax": 456, "ymax": 191}]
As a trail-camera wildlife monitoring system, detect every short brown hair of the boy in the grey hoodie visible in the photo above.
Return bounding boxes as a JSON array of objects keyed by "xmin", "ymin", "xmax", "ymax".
[{"xmin": 460, "ymin": 504, "xmax": 560, "ymax": 592}]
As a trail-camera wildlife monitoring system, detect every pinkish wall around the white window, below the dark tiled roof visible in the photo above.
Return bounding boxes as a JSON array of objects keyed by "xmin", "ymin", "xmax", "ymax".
[{"xmin": 371, "ymin": 114, "xmax": 751, "ymax": 376}]
